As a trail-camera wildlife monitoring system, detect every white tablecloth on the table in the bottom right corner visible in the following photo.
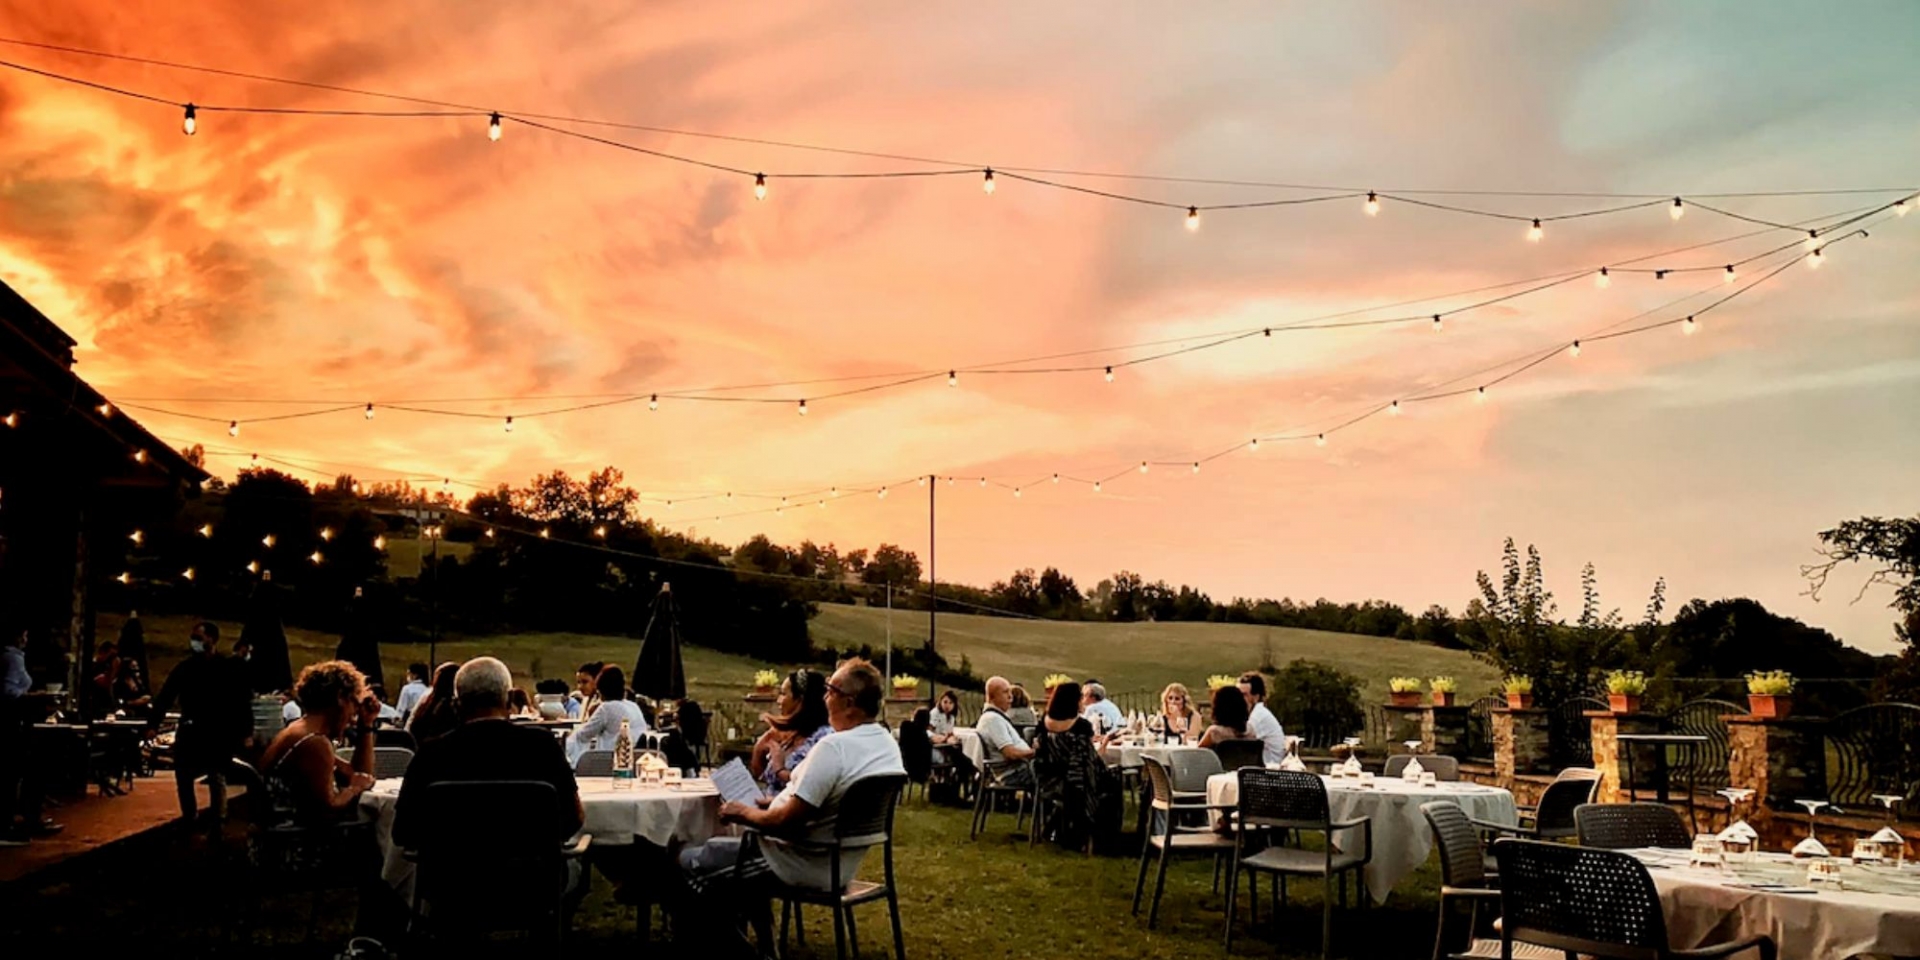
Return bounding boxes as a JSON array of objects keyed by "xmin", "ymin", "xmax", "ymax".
[{"xmin": 1628, "ymin": 851, "xmax": 1920, "ymax": 960}]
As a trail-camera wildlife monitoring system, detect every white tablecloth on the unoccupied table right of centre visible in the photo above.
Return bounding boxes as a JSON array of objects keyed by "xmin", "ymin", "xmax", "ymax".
[{"xmin": 1206, "ymin": 774, "xmax": 1519, "ymax": 902}]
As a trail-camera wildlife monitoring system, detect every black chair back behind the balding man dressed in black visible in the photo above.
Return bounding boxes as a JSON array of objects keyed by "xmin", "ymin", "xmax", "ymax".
[{"xmin": 405, "ymin": 780, "xmax": 593, "ymax": 943}]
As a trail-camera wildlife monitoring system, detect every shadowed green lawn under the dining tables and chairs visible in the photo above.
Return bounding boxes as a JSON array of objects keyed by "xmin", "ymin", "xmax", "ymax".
[{"xmin": 0, "ymin": 783, "xmax": 1438, "ymax": 960}]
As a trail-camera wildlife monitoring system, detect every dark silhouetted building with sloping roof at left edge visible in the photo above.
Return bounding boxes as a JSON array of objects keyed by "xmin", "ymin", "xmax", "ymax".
[{"xmin": 0, "ymin": 282, "xmax": 207, "ymax": 689}]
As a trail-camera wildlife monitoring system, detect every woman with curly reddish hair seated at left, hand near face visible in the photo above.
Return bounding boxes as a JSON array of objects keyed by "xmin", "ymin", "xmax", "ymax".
[{"xmin": 259, "ymin": 660, "xmax": 380, "ymax": 822}]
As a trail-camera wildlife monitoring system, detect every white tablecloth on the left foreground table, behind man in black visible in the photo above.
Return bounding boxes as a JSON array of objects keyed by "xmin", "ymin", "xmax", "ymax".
[{"xmin": 361, "ymin": 778, "xmax": 722, "ymax": 897}]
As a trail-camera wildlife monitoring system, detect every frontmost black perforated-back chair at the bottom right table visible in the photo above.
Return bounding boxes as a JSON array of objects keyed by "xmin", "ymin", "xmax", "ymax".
[{"xmin": 1457, "ymin": 841, "xmax": 1776, "ymax": 960}]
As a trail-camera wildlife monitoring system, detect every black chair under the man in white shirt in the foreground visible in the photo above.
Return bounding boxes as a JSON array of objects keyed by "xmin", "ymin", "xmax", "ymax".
[{"xmin": 756, "ymin": 774, "xmax": 908, "ymax": 960}]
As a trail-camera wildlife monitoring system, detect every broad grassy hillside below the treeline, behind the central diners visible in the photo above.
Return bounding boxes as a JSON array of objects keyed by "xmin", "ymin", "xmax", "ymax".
[{"xmin": 812, "ymin": 603, "xmax": 1500, "ymax": 703}]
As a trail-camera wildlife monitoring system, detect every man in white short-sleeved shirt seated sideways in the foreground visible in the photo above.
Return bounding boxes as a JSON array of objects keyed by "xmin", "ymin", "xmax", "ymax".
[{"xmin": 674, "ymin": 659, "xmax": 906, "ymax": 948}]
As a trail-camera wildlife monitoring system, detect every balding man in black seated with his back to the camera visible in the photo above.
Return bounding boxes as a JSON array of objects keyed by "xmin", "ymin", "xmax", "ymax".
[{"xmin": 394, "ymin": 657, "xmax": 586, "ymax": 849}]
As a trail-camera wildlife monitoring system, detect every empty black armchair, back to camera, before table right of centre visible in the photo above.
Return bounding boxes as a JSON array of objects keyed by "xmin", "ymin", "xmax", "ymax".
[{"xmin": 1227, "ymin": 766, "xmax": 1373, "ymax": 958}]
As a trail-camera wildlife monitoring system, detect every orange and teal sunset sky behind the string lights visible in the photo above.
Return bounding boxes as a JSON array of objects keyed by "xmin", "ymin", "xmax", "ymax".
[{"xmin": 0, "ymin": 0, "xmax": 1920, "ymax": 653}]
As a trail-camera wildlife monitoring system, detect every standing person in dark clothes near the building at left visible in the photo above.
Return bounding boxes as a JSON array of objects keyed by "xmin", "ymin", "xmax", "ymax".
[{"xmin": 154, "ymin": 620, "xmax": 253, "ymax": 829}]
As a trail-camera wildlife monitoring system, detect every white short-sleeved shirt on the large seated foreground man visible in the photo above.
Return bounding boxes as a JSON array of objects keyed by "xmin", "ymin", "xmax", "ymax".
[{"xmin": 760, "ymin": 724, "xmax": 906, "ymax": 891}]
